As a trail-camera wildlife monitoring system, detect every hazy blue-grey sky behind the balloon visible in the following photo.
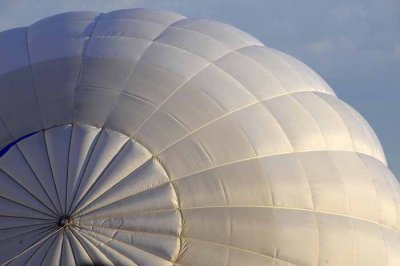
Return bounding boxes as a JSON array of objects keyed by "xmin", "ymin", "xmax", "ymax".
[{"xmin": 0, "ymin": 0, "xmax": 400, "ymax": 177}]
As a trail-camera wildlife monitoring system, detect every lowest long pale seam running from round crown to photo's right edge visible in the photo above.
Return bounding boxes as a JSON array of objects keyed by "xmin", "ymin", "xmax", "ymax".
[{"xmin": 182, "ymin": 205, "xmax": 400, "ymax": 234}]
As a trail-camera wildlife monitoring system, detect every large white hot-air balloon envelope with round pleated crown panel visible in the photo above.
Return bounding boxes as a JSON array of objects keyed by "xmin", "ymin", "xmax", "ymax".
[{"xmin": 0, "ymin": 9, "xmax": 400, "ymax": 266}]
